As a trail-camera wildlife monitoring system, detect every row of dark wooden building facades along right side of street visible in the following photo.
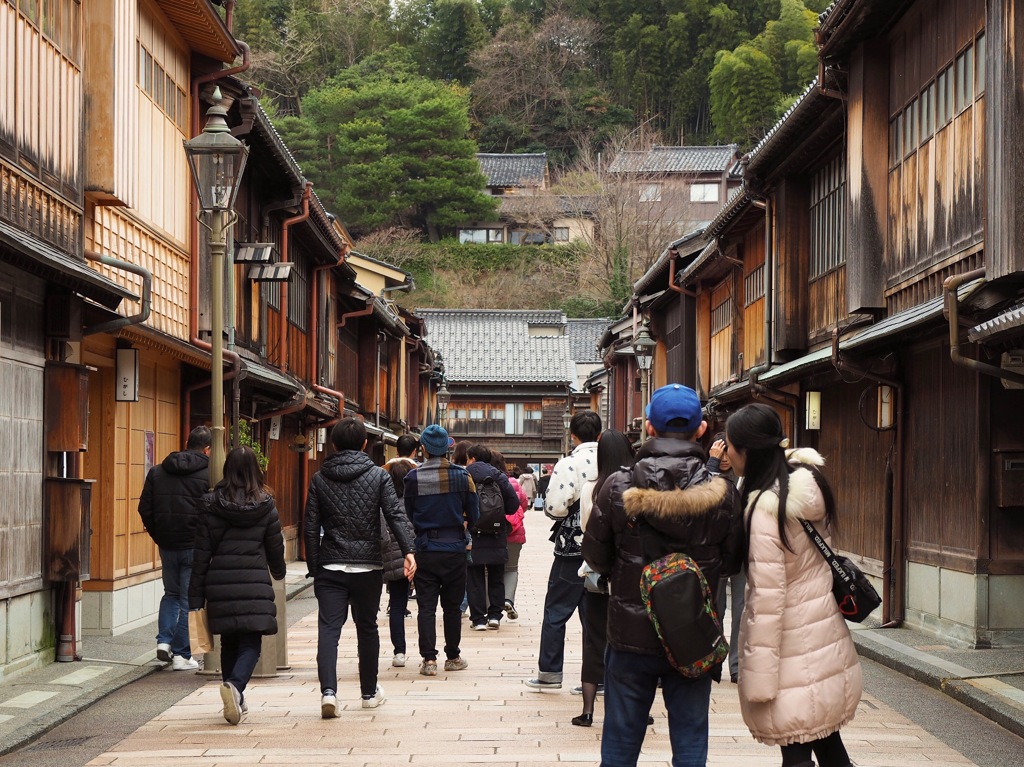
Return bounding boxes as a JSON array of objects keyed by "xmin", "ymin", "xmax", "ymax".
[{"xmin": 614, "ymin": 0, "xmax": 1024, "ymax": 647}]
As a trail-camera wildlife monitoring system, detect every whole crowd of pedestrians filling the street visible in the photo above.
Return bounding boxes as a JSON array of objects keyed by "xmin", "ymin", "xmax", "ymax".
[{"xmin": 139, "ymin": 384, "xmax": 861, "ymax": 767}]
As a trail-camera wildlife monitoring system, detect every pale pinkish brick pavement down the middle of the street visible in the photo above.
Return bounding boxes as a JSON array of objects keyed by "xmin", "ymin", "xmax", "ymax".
[{"xmin": 83, "ymin": 512, "xmax": 974, "ymax": 767}]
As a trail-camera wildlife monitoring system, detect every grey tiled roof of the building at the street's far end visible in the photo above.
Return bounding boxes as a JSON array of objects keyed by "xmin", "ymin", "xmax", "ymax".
[{"xmin": 416, "ymin": 308, "xmax": 575, "ymax": 386}]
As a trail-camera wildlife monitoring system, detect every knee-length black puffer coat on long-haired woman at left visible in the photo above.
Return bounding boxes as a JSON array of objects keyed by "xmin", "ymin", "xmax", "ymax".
[{"xmin": 188, "ymin": 488, "xmax": 287, "ymax": 634}]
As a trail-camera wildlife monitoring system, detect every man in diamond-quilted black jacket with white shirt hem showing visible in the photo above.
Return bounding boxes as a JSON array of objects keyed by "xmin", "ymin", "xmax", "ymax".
[{"xmin": 304, "ymin": 418, "xmax": 416, "ymax": 719}]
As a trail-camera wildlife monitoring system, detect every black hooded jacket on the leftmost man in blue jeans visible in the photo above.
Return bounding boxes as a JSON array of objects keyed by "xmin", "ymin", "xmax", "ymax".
[{"xmin": 138, "ymin": 451, "xmax": 210, "ymax": 551}]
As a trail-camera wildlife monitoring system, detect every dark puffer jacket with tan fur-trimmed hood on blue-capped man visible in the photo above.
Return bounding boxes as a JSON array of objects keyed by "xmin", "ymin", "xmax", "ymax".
[{"xmin": 583, "ymin": 437, "xmax": 743, "ymax": 655}]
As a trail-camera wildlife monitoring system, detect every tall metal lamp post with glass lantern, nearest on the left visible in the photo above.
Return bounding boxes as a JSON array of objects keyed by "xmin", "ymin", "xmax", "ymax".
[{"xmin": 183, "ymin": 88, "xmax": 249, "ymax": 485}]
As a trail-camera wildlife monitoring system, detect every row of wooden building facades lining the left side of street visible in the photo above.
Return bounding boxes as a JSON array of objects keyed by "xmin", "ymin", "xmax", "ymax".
[{"xmin": 0, "ymin": 0, "xmax": 434, "ymax": 678}]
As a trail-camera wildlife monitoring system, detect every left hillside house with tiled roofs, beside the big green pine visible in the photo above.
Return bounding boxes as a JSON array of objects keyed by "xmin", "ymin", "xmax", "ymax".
[{"xmin": 459, "ymin": 154, "xmax": 594, "ymax": 245}]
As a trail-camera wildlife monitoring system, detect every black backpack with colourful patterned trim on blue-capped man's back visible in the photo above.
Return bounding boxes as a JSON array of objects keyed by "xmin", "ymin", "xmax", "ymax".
[{"xmin": 640, "ymin": 553, "xmax": 729, "ymax": 679}]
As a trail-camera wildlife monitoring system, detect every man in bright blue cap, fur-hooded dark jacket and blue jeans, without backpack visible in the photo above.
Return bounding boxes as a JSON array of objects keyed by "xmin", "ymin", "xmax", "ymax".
[{"xmin": 583, "ymin": 384, "xmax": 743, "ymax": 767}]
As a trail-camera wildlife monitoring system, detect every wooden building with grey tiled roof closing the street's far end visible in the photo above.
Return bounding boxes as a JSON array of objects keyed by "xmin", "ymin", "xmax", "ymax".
[{"xmin": 416, "ymin": 308, "xmax": 607, "ymax": 465}]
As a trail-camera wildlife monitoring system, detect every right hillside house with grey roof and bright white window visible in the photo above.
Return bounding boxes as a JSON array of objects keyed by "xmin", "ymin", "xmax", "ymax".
[{"xmin": 607, "ymin": 143, "xmax": 741, "ymax": 236}]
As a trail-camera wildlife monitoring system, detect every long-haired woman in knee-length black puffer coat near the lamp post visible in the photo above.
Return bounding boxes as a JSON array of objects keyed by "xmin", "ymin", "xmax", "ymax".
[{"xmin": 188, "ymin": 448, "xmax": 286, "ymax": 724}]
